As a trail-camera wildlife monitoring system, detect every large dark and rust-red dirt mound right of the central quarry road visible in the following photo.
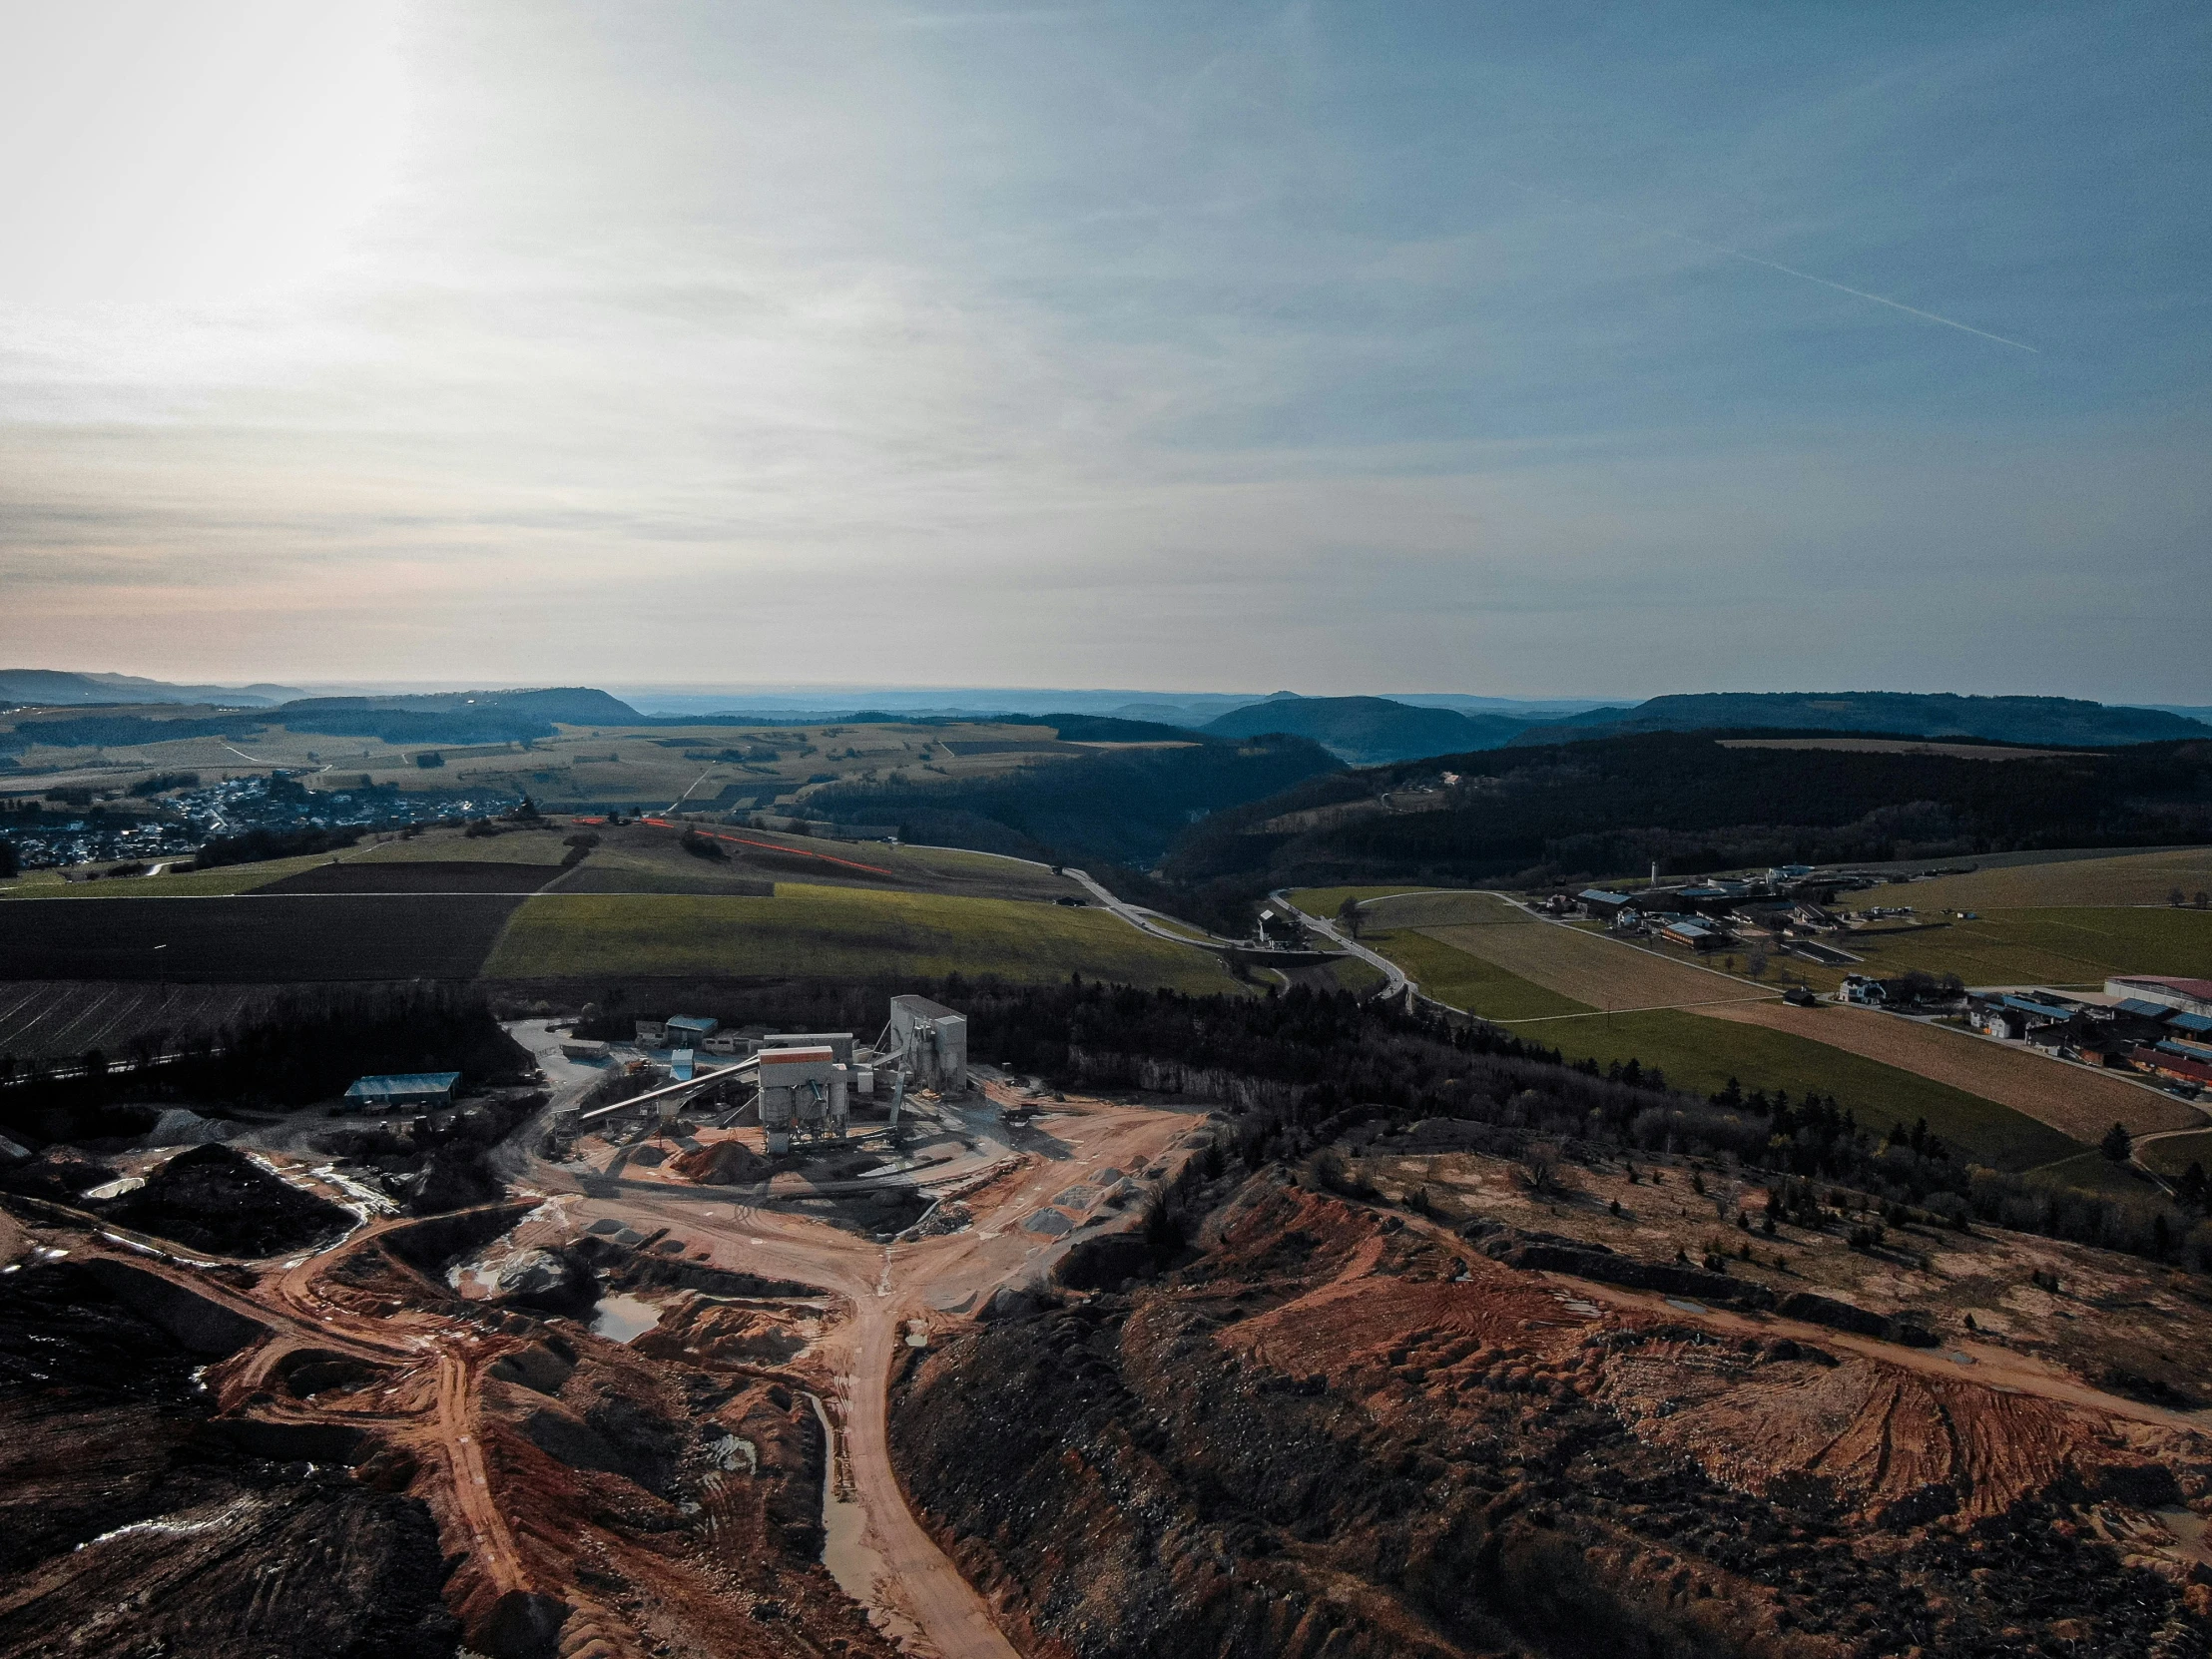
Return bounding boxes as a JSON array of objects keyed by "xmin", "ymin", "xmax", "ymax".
[{"xmin": 891, "ymin": 1175, "xmax": 2212, "ymax": 1659}]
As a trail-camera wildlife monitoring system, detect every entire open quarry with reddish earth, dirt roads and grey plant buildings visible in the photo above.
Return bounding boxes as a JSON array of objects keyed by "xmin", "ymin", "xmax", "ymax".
[{"xmin": 0, "ymin": 995, "xmax": 2212, "ymax": 1659}]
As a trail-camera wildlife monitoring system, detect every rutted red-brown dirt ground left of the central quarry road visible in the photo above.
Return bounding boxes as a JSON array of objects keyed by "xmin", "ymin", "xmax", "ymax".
[{"xmin": 0, "ymin": 1184, "xmax": 891, "ymax": 1659}]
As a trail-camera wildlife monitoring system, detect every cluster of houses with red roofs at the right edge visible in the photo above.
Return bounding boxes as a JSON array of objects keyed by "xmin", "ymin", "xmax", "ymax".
[{"xmin": 1966, "ymin": 975, "xmax": 2212, "ymax": 1088}]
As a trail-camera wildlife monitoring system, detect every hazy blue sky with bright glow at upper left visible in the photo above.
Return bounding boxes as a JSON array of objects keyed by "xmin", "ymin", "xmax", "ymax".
[{"xmin": 0, "ymin": 0, "xmax": 2212, "ymax": 704}]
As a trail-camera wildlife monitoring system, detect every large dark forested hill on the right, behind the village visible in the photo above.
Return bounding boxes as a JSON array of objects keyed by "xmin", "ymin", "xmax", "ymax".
[{"xmin": 1166, "ymin": 732, "xmax": 2212, "ymax": 891}]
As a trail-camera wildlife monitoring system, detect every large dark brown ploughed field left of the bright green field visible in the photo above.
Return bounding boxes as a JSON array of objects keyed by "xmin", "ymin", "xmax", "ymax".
[{"xmin": 0, "ymin": 897, "xmax": 524, "ymax": 984}]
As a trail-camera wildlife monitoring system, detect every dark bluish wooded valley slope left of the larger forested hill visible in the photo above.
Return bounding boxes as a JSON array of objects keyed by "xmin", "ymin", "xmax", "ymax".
[{"xmin": 808, "ymin": 735, "xmax": 1341, "ymax": 867}]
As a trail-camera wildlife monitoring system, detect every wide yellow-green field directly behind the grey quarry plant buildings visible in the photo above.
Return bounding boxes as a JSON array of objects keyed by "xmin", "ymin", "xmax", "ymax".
[{"xmin": 484, "ymin": 882, "xmax": 1237, "ymax": 991}]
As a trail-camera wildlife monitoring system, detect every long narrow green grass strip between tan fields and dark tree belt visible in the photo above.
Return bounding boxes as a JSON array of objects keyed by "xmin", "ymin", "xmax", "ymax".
[{"xmin": 1372, "ymin": 933, "xmax": 2077, "ymax": 1170}]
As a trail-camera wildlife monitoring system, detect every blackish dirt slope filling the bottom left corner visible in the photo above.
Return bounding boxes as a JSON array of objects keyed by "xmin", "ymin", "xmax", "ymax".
[{"xmin": 0, "ymin": 1261, "xmax": 460, "ymax": 1659}]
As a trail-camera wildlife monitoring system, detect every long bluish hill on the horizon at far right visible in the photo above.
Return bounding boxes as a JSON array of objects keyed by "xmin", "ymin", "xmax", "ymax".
[{"xmin": 1512, "ymin": 693, "xmax": 2212, "ymax": 748}]
